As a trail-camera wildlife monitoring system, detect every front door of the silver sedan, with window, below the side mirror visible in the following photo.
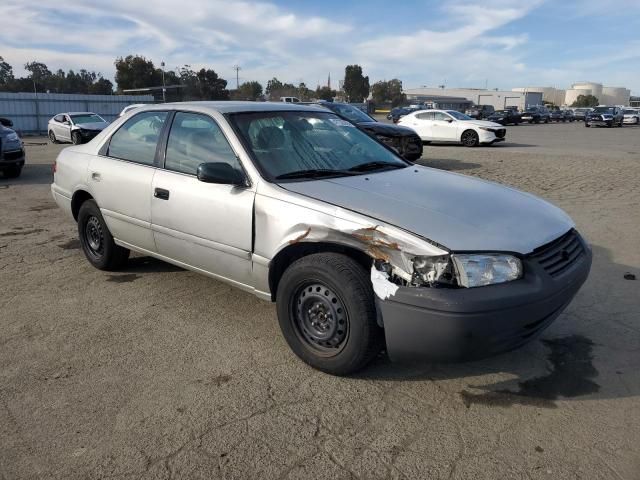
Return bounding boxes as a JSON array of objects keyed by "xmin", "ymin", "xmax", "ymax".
[{"xmin": 151, "ymin": 112, "xmax": 255, "ymax": 285}]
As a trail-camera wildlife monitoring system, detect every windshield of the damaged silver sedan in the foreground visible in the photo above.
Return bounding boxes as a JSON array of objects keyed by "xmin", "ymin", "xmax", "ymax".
[{"xmin": 229, "ymin": 111, "xmax": 408, "ymax": 180}]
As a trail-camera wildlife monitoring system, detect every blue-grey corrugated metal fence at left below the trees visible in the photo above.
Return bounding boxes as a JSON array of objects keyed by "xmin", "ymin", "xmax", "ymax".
[{"xmin": 0, "ymin": 92, "xmax": 154, "ymax": 134}]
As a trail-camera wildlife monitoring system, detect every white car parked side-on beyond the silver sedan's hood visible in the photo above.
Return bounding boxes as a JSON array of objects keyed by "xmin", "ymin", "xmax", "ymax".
[{"xmin": 398, "ymin": 110, "xmax": 507, "ymax": 147}]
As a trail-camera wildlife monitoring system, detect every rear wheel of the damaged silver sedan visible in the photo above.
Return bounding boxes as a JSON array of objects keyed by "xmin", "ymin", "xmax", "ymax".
[{"xmin": 78, "ymin": 200, "xmax": 130, "ymax": 271}]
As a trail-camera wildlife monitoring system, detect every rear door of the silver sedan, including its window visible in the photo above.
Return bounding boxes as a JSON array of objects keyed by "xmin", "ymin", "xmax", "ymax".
[{"xmin": 87, "ymin": 111, "xmax": 168, "ymax": 252}]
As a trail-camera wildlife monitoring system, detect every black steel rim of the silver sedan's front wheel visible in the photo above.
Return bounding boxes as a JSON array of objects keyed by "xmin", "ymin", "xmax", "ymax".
[{"xmin": 291, "ymin": 281, "xmax": 350, "ymax": 357}]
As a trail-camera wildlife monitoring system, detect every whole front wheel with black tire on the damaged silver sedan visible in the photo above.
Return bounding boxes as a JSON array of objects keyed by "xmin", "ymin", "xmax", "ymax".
[{"xmin": 276, "ymin": 253, "xmax": 384, "ymax": 375}]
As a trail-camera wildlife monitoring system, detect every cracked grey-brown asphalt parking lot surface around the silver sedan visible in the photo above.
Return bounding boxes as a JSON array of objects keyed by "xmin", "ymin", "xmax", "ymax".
[{"xmin": 0, "ymin": 123, "xmax": 640, "ymax": 480}]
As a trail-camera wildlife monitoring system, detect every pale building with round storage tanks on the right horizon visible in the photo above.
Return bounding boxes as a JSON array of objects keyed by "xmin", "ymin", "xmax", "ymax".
[{"xmin": 513, "ymin": 82, "xmax": 631, "ymax": 106}]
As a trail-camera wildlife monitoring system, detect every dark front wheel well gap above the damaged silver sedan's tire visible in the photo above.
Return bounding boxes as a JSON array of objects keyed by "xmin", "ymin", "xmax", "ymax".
[{"xmin": 269, "ymin": 242, "xmax": 373, "ymax": 301}]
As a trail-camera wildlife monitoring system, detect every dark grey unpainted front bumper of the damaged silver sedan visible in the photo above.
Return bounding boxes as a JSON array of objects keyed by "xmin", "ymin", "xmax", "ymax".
[{"xmin": 376, "ymin": 234, "xmax": 591, "ymax": 361}]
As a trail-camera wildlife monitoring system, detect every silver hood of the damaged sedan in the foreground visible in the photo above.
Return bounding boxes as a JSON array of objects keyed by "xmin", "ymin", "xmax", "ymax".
[{"xmin": 281, "ymin": 165, "xmax": 574, "ymax": 254}]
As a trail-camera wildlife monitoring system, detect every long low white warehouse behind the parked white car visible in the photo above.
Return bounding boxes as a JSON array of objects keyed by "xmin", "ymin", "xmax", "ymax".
[{"xmin": 403, "ymin": 87, "xmax": 542, "ymax": 111}]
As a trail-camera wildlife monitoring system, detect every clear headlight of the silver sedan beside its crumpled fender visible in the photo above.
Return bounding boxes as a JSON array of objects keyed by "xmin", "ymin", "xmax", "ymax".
[{"xmin": 451, "ymin": 253, "xmax": 522, "ymax": 288}]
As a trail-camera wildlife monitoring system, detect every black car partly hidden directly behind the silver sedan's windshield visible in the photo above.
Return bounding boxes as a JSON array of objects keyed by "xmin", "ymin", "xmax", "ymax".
[{"xmin": 320, "ymin": 102, "xmax": 422, "ymax": 162}]
